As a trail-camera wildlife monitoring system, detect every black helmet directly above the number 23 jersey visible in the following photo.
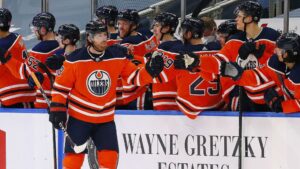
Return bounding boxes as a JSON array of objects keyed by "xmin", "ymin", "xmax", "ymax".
[{"xmin": 181, "ymin": 18, "xmax": 204, "ymax": 38}]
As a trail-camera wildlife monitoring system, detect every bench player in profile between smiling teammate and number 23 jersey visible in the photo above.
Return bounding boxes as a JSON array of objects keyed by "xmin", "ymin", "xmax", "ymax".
[{"xmin": 152, "ymin": 12, "xmax": 182, "ymax": 110}]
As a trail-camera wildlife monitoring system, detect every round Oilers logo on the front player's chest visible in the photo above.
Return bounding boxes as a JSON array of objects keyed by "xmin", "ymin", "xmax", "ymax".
[{"xmin": 86, "ymin": 70, "xmax": 111, "ymax": 96}]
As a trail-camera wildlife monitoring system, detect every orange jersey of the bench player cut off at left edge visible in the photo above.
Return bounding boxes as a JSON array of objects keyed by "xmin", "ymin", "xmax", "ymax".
[{"xmin": 0, "ymin": 33, "xmax": 35, "ymax": 106}]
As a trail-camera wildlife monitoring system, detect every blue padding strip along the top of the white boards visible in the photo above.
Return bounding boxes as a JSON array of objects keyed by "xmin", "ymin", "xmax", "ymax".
[{"xmin": 0, "ymin": 108, "xmax": 300, "ymax": 118}]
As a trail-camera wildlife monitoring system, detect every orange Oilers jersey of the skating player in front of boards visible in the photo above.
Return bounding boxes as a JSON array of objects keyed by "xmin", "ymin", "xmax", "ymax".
[{"xmin": 51, "ymin": 46, "xmax": 153, "ymax": 123}]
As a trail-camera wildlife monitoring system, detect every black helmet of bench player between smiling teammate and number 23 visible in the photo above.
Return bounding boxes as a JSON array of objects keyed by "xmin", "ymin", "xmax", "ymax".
[{"xmin": 154, "ymin": 12, "xmax": 178, "ymax": 33}]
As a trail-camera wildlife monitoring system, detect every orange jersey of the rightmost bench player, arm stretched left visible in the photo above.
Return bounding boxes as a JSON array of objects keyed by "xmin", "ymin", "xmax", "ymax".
[{"xmin": 238, "ymin": 55, "xmax": 300, "ymax": 113}]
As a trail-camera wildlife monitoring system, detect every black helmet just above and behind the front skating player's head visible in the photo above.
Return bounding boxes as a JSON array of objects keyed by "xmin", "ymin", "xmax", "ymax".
[{"xmin": 96, "ymin": 5, "xmax": 118, "ymax": 26}]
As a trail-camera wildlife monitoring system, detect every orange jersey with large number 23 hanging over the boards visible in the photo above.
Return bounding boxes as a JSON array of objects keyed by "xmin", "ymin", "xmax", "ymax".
[{"xmin": 158, "ymin": 45, "xmax": 224, "ymax": 119}]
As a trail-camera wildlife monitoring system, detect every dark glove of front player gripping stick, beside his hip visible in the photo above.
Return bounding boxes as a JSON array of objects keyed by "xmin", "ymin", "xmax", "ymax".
[{"xmin": 49, "ymin": 102, "xmax": 67, "ymax": 129}]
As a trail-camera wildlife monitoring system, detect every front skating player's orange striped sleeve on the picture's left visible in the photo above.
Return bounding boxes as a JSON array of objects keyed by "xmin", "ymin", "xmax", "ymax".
[{"xmin": 51, "ymin": 61, "xmax": 76, "ymax": 104}]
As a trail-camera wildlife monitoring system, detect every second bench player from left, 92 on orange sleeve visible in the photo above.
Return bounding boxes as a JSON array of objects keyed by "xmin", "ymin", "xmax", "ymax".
[{"xmin": 26, "ymin": 12, "xmax": 59, "ymax": 108}]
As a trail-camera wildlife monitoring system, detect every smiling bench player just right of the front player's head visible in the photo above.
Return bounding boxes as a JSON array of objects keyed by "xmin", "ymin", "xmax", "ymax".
[{"xmin": 117, "ymin": 9, "xmax": 158, "ymax": 110}]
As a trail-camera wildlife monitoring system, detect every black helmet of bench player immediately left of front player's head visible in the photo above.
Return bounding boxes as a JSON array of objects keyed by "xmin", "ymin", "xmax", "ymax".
[{"xmin": 57, "ymin": 24, "xmax": 80, "ymax": 44}]
